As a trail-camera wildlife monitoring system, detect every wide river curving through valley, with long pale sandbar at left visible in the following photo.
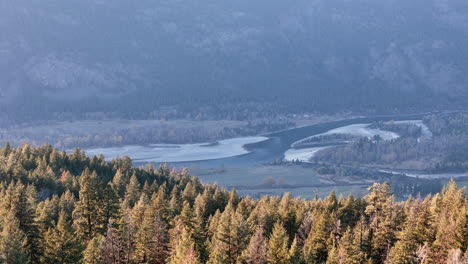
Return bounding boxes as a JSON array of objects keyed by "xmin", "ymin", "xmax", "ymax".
[{"xmin": 86, "ymin": 114, "xmax": 424, "ymax": 168}]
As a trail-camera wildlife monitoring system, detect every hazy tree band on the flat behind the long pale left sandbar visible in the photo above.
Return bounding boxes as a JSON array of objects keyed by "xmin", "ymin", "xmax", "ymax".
[{"xmin": 0, "ymin": 117, "xmax": 295, "ymax": 149}]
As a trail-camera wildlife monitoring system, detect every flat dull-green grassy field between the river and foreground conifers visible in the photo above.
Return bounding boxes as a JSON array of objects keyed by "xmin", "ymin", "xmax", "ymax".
[{"xmin": 191, "ymin": 165, "xmax": 371, "ymax": 198}]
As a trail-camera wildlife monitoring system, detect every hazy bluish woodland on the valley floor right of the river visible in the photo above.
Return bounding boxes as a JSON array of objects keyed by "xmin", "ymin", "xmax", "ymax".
[{"xmin": 315, "ymin": 113, "xmax": 468, "ymax": 173}]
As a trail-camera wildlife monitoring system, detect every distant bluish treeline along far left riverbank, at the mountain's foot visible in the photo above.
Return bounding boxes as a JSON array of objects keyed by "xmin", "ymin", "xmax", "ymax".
[{"xmin": 0, "ymin": 108, "xmax": 296, "ymax": 149}]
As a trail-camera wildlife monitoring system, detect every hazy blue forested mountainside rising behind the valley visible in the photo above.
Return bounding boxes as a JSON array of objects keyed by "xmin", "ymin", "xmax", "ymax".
[{"xmin": 0, "ymin": 0, "xmax": 468, "ymax": 121}]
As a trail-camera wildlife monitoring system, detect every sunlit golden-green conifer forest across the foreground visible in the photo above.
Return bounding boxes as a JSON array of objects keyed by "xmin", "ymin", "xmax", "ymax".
[{"xmin": 0, "ymin": 144, "xmax": 468, "ymax": 264}]
